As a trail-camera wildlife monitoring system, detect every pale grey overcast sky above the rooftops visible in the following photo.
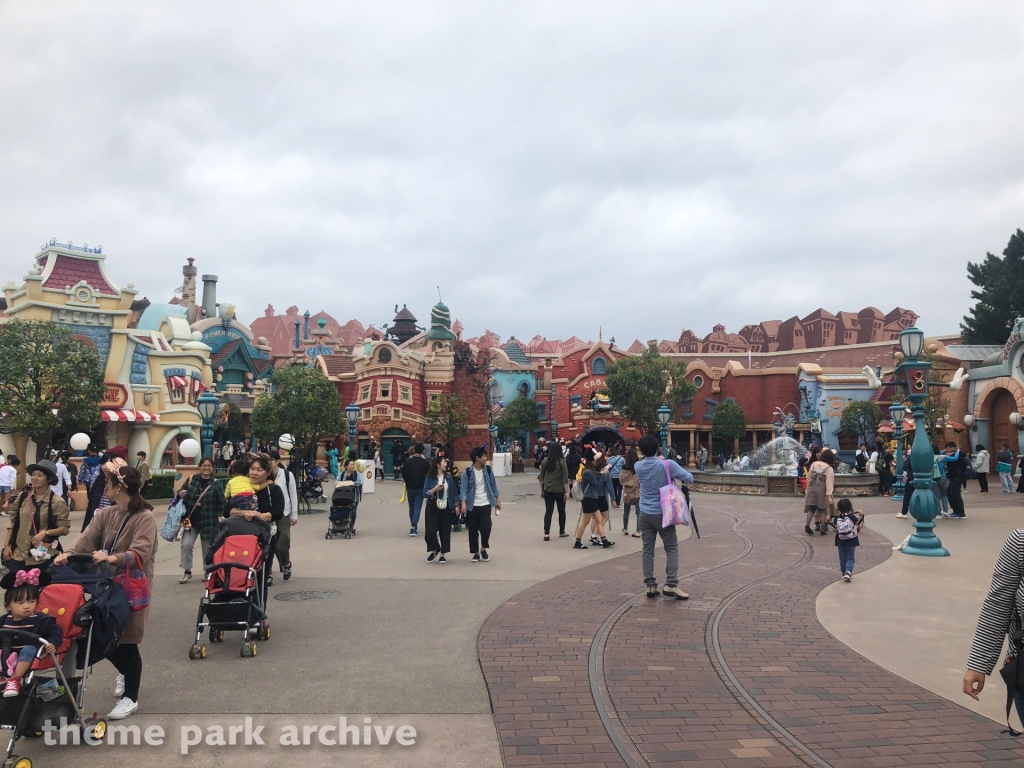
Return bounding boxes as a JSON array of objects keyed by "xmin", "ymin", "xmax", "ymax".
[{"xmin": 0, "ymin": 0, "xmax": 1024, "ymax": 343}]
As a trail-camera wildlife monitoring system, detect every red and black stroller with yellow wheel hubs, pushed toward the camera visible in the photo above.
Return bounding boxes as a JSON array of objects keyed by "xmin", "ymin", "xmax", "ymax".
[{"xmin": 188, "ymin": 517, "xmax": 271, "ymax": 660}]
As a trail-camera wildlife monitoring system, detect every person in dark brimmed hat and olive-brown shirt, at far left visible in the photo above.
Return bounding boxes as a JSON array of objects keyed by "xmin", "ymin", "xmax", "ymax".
[{"xmin": 3, "ymin": 461, "xmax": 71, "ymax": 570}]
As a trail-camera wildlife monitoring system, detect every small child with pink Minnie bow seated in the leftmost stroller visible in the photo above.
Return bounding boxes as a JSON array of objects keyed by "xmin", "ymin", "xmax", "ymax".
[{"xmin": 0, "ymin": 568, "xmax": 63, "ymax": 698}]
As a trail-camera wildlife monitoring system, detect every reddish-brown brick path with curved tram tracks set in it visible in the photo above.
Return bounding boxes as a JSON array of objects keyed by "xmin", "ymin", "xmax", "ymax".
[{"xmin": 478, "ymin": 495, "xmax": 1024, "ymax": 768}]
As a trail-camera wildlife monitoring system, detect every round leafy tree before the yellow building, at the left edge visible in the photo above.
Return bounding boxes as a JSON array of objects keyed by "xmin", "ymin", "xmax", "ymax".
[{"xmin": 0, "ymin": 319, "xmax": 105, "ymax": 462}]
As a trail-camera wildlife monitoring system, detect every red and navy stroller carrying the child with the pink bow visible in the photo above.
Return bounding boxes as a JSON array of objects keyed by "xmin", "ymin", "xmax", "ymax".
[{"xmin": 0, "ymin": 555, "xmax": 129, "ymax": 768}]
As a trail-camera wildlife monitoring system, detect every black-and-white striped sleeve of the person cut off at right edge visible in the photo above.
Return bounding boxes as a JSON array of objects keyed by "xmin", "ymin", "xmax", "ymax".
[{"xmin": 967, "ymin": 528, "xmax": 1024, "ymax": 675}]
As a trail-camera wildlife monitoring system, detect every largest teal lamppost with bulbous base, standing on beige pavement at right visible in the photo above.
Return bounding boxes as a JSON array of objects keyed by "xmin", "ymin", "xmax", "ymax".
[{"xmin": 896, "ymin": 326, "xmax": 949, "ymax": 557}]
